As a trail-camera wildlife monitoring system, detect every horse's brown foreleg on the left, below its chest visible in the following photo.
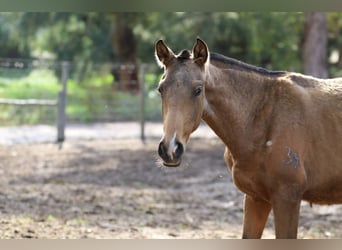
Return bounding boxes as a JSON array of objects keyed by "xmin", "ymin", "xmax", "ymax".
[{"xmin": 242, "ymin": 195, "xmax": 272, "ymax": 239}]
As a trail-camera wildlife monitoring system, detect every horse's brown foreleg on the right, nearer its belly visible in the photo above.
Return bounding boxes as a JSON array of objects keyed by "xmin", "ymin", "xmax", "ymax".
[{"xmin": 272, "ymin": 195, "xmax": 300, "ymax": 239}]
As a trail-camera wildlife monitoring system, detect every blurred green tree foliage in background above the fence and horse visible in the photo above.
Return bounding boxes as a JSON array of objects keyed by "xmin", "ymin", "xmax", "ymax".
[{"xmin": 0, "ymin": 12, "xmax": 342, "ymax": 71}]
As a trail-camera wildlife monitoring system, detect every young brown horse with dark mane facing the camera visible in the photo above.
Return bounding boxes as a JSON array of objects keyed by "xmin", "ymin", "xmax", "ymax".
[{"xmin": 155, "ymin": 39, "xmax": 342, "ymax": 238}]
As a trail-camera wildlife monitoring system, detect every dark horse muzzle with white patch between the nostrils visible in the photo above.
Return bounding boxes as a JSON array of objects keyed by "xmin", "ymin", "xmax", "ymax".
[{"xmin": 158, "ymin": 141, "xmax": 184, "ymax": 167}]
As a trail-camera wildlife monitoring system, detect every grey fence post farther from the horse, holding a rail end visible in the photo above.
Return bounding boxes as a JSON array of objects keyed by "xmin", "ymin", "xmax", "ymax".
[{"xmin": 57, "ymin": 61, "xmax": 69, "ymax": 142}]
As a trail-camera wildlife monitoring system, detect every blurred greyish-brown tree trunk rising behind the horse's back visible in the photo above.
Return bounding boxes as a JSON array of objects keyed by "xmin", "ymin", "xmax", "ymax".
[{"xmin": 303, "ymin": 12, "xmax": 328, "ymax": 78}]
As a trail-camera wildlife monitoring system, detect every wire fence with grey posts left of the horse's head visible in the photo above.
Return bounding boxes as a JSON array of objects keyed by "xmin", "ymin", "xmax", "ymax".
[{"xmin": 0, "ymin": 58, "xmax": 160, "ymax": 141}]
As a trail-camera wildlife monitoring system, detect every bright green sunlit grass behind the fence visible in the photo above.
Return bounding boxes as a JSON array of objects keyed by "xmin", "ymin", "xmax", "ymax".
[{"xmin": 0, "ymin": 69, "xmax": 161, "ymax": 125}]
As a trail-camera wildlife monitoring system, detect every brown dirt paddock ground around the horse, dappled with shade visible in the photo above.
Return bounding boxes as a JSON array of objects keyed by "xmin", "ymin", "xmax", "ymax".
[{"xmin": 0, "ymin": 139, "xmax": 342, "ymax": 238}]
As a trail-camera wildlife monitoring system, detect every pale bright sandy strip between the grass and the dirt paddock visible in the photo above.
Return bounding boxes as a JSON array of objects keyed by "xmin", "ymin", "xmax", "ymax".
[{"xmin": 0, "ymin": 122, "xmax": 216, "ymax": 145}]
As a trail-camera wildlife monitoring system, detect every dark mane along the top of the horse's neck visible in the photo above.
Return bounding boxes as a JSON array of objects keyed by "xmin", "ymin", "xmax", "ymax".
[{"xmin": 210, "ymin": 53, "xmax": 286, "ymax": 76}]
